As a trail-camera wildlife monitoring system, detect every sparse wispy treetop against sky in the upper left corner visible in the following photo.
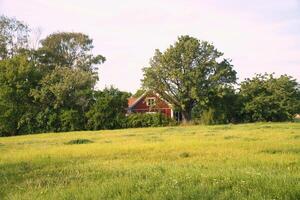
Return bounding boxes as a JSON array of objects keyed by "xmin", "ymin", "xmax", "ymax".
[{"xmin": 0, "ymin": 16, "xmax": 30, "ymax": 60}]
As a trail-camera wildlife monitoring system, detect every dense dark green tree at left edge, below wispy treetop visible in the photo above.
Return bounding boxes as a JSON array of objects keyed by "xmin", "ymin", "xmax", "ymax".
[{"xmin": 0, "ymin": 55, "xmax": 41, "ymax": 136}]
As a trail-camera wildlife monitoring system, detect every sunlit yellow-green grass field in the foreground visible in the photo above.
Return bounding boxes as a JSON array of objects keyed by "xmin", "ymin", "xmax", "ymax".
[{"xmin": 0, "ymin": 123, "xmax": 300, "ymax": 200}]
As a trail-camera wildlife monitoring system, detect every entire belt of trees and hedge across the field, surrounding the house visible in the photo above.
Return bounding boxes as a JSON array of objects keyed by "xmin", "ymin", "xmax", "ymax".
[{"xmin": 0, "ymin": 16, "xmax": 300, "ymax": 136}]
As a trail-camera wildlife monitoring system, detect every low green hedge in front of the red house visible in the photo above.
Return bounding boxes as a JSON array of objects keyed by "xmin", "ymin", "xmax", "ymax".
[{"xmin": 127, "ymin": 113, "xmax": 175, "ymax": 128}]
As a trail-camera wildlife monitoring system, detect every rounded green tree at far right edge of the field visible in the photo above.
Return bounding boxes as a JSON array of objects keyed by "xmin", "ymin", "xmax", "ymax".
[{"xmin": 239, "ymin": 74, "xmax": 300, "ymax": 122}]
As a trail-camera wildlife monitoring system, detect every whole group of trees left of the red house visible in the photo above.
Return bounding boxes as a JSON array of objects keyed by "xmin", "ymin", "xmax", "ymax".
[{"xmin": 0, "ymin": 16, "xmax": 142, "ymax": 136}]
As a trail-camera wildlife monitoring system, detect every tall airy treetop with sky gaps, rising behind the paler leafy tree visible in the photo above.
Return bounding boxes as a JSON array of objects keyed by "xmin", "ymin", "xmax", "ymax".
[{"xmin": 39, "ymin": 32, "xmax": 105, "ymax": 78}]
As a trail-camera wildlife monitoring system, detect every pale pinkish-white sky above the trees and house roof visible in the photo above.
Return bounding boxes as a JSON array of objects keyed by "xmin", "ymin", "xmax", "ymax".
[{"xmin": 0, "ymin": 0, "xmax": 300, "ymax": 92}]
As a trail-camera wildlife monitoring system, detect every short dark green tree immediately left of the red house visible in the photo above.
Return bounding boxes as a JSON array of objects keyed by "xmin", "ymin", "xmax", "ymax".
[{"xmin": 86, "ymin": 87, "xmax": 130, "ymax": 130}]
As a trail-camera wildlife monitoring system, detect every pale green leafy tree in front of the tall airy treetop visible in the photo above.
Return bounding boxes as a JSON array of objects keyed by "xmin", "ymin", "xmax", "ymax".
[{"xmin": 31, "ymin": 67, "xmax": 95, "ymax": 131}]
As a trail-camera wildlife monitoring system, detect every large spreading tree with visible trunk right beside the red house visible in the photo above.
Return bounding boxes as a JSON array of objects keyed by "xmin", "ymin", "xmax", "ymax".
[{"xmin": 142, "ymin": 36, "xmax": 236, "ymax": 121}]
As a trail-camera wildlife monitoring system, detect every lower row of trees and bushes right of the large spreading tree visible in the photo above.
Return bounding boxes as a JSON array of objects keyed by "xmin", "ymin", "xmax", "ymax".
[{"xmin": 193, "ymin": 74, "xmax": 300, "ymax": 124}]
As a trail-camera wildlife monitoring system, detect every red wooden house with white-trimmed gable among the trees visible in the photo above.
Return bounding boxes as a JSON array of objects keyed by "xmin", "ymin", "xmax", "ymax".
[{"xmin": 127, "ymin": 90, "xmax": 173, "ymax": 118}]
